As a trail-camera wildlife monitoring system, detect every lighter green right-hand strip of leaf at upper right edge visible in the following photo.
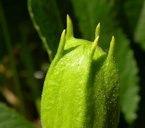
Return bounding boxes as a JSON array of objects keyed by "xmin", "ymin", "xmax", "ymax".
[{"xmin": 135, "ymin": 1, "xmax": 145, "ymax": 50}]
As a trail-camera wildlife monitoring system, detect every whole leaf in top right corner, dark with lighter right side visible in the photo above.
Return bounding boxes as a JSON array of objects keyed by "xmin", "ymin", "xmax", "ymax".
[{"xmin": 119, "ymin": 0, "xmax": 145, "ymax": 50}]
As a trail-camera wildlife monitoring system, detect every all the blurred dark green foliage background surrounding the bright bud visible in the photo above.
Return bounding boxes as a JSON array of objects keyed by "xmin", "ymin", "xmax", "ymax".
[{"xmin": 0, "ymin": 0, "xmax": 145, "ymax": 128}]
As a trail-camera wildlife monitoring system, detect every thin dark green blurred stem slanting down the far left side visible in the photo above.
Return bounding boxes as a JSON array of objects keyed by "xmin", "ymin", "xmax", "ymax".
[{"xmin": 0, "ymin": 1, "xmax": 25, "ymax": 114}]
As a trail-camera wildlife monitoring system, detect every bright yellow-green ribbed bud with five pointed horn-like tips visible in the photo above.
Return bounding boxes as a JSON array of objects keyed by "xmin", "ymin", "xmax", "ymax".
[{"xmin": 41, "ymin": 16, "xmax": 119, "ymax": 128}]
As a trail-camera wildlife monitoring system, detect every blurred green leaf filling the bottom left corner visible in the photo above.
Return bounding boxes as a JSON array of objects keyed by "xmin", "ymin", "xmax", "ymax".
[{"xmin": 0, "ymin": 103, "xmax": 35, "ymax": 128}]
